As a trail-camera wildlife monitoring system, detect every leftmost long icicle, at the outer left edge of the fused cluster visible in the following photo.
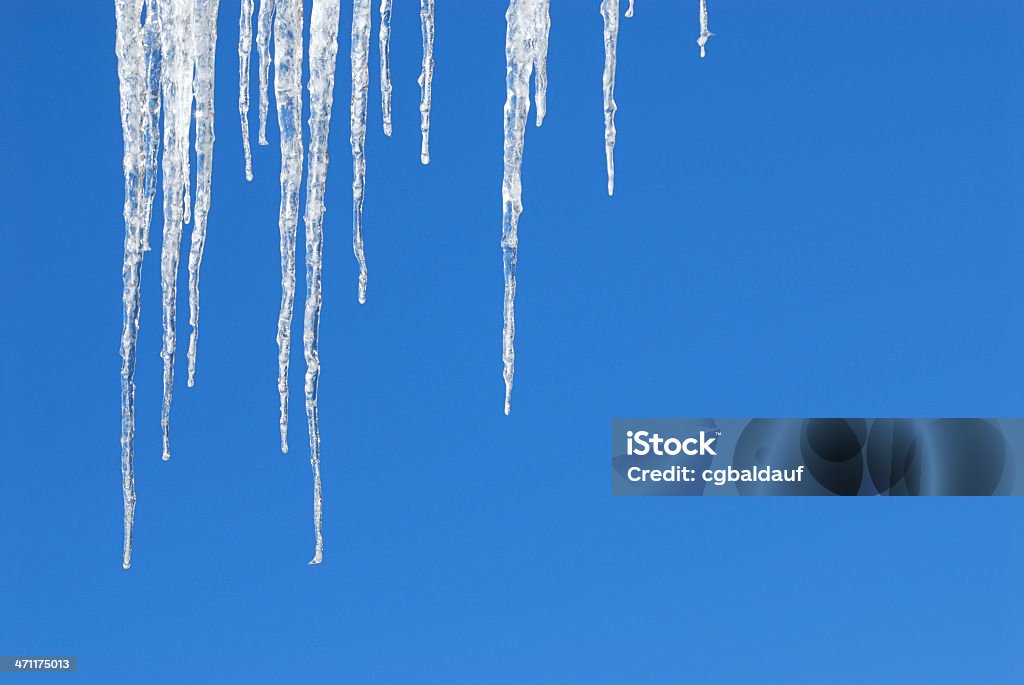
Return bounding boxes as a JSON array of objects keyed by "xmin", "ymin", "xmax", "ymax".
[{"xmin": 114, "ymin": 0, "xmax": 153, "ymax": 568}]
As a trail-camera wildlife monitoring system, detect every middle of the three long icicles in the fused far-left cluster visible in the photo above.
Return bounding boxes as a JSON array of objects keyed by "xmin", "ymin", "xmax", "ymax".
[{"xmin": 157, "ymin": 0, "xmax": 195, "ymax": 461}]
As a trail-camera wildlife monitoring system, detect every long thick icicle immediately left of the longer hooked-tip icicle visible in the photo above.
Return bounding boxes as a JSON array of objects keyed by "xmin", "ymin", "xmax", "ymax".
[{"xmin": 273, "ymin": 0, "xmax": 302, "ymax": 453}]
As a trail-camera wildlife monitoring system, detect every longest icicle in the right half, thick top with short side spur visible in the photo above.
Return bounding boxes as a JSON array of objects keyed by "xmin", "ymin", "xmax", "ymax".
[{"xmin": 502, "ymin": 0, "xmax": 550, "ymax": 415}]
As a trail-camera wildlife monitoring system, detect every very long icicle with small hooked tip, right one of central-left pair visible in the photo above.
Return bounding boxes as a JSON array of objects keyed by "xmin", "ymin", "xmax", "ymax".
[{"xmin": 302, "ymin": 0, "xmax": 341, "ymax": 564}]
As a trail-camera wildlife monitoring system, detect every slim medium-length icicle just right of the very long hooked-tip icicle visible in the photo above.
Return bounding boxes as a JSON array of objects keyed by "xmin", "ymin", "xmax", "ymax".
[{"xmin": 349, "ymin": 0, "xmax": 370, "ymax": 304}]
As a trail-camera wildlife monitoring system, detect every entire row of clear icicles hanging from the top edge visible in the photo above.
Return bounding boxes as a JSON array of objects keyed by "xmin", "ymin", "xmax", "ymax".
[{"xmin": 115, "ymin": 0, "xmax": 714, "ymax": 568}]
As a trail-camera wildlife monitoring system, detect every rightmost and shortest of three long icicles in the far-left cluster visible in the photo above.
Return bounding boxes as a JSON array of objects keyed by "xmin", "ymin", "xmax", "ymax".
[{"xmin": 188, "ymin": 0, "xmax": 220, "ymax": 387}]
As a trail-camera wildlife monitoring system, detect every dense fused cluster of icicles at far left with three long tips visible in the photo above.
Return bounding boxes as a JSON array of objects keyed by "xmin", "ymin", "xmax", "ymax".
[{"xmin": 115, "ymin": 0, "xmax": 219, "ymax": 568}]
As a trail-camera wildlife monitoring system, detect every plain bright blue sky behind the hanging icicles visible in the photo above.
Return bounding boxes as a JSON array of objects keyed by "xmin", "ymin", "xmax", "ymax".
[{"xmin": 0, "ymin": 0, "xmax": 1024, "ymax": 684}]
